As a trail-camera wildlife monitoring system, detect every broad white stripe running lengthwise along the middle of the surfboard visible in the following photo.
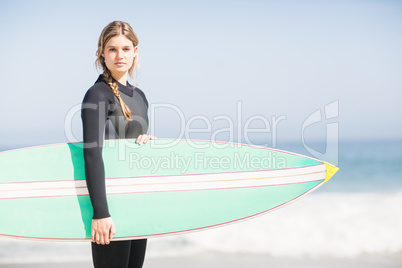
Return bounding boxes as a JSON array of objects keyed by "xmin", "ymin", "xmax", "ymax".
[{"xmin": 0, "ymin": 165, "xmax": 326, "ymax": 199}]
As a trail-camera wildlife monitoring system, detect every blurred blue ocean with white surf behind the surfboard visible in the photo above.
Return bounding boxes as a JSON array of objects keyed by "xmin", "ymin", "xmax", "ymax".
[{"xmin": 0, "ymin": 140, "xmax": 402, "ymax": 267}]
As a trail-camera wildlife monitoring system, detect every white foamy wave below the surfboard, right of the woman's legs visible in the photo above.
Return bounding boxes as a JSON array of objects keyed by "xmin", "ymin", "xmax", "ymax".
[{"xmin": 148, "ymin": 192, "xmax": 402, "ymax": 258}]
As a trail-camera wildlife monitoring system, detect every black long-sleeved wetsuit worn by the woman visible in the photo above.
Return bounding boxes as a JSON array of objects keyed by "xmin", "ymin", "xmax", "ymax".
[{"xmin": 81, "ymin": 75, "xmax": 148, "ymax": 268}]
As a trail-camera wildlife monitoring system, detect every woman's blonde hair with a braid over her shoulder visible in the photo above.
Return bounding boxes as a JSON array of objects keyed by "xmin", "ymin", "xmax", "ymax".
[{"xmin": 95, "ymin": 21, "xmax": 139, "ymax": 121}]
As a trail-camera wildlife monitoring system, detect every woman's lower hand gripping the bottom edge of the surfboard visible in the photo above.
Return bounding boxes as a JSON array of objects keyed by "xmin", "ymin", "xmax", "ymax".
[{"xmin": 91, "ymin": 217, "xmax": 116, "ymax": 245}]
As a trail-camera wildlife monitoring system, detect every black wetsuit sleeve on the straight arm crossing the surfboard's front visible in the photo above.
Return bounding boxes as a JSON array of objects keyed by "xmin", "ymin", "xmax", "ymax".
[{"xmin": 81, "ymin": 88, "xmax": 110, "ymax": 219}]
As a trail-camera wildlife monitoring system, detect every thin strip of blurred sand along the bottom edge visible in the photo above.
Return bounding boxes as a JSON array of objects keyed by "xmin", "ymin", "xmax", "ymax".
[{"xmin": 0, "ymin": 253, "xmax": 402, "ymax": 268}]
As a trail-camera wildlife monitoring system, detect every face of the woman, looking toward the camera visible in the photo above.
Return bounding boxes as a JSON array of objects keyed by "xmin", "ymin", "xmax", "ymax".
[{"xmin": 102, "ymin": 35, "xmax": 137, "ymax": 76}]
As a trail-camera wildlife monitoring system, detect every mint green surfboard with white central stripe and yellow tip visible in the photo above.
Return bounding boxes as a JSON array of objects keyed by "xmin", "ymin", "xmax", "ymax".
[{"xmin": 0, "ymin": 139, "xmax": 338, "ymax": 241}]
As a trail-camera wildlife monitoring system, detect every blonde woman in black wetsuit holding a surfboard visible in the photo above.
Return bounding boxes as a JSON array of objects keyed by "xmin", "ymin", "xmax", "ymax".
[{"xmin": 81, "ymin": 21, "xmax": 153, "ymax": 268}]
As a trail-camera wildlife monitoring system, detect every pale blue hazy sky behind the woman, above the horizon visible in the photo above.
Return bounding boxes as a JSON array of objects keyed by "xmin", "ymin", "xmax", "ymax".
[{"xmin": 0, "ymin": 0, "xmax": 402, "ymax": 149}]
